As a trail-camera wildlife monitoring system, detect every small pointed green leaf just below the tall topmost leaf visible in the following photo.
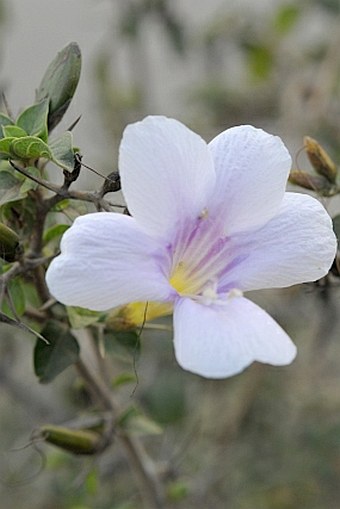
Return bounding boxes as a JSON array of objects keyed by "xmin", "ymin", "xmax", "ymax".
[{"xmin": 16, "ymin": 99, "xmax": 48, "ymax": 141}]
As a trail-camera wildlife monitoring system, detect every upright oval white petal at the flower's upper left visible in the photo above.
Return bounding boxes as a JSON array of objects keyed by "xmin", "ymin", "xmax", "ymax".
[{"xmin": 119, "ymin": 116, "xmax": 215, "ymax": 238}]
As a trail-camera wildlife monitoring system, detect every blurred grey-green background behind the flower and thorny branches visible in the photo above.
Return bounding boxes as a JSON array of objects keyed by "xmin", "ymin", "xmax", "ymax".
[{"xmin": 0, "ymin": 0, "xmax": 340, "ymax": 509}]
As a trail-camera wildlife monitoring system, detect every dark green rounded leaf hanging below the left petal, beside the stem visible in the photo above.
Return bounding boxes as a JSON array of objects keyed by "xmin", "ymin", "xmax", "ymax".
[{"xmin": 34, "ymin": 320, "xmax": 80, "ymax": 383}]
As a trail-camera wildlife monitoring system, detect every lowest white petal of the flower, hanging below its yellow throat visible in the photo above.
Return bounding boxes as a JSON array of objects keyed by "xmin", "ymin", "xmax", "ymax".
[{"xmin": 174, "ymin": 297, "xmax": 296, "ymax": 378}]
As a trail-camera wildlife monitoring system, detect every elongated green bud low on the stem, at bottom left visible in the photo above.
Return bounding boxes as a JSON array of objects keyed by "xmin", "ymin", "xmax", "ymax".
[{"xmin": 38, "ymin": 424, "xmax": 108, "ymax": 454}]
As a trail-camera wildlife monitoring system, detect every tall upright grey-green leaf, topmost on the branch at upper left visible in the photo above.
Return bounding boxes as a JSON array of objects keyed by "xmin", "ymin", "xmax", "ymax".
[{"xmin": 36, "ymin": 42, "xmax": 81, "ymax": 130}]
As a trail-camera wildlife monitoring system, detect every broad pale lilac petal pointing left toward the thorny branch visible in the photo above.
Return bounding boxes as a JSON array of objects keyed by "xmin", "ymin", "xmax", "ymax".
[{"xmin": 46, "ymin": 212, "xmax": 174, "ymax": 311}]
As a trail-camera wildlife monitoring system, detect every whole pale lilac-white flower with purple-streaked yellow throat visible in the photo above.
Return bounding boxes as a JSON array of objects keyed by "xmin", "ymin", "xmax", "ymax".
[{"xmin": 47, "ymin": 117, "xmax": 336, "ymax": 378}]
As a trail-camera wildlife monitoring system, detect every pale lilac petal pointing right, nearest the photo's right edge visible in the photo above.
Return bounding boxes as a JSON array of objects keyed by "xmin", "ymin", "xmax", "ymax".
[{"xmin": 219, "ymin": 193, "xmax": 337, "ymax": 292}]
